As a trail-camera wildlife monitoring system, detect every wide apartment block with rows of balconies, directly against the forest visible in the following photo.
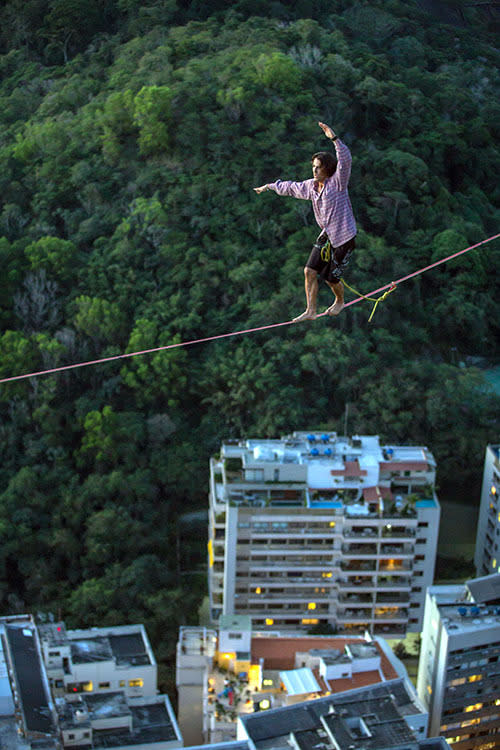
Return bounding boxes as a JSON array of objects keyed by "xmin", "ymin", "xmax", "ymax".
[{"xmin": 208, "ymin": 432, "xmax": 440, "ymax": 637}]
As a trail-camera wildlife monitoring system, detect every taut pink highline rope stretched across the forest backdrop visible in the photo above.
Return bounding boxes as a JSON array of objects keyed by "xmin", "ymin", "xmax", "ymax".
[{"xmin": 0, "ymin": 234, "xmax": 500, "ymax": 383}]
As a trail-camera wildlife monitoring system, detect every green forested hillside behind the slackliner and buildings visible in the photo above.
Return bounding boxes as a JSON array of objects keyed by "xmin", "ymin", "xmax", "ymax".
[{"xmin": 0, "ymin": 0, "xmax": 500, "ymax": 692}]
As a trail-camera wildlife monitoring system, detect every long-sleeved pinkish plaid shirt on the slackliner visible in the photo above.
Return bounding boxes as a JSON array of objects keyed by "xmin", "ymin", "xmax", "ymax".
[{"xmin": 267, "ymin": 138, "xmax": 356, "ymax": 247}]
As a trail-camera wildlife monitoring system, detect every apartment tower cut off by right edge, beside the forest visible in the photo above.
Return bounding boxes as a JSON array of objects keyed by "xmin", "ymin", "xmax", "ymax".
[{"xmin": 474, "ymin": 445, "xmax": 500, "ymax": 576}]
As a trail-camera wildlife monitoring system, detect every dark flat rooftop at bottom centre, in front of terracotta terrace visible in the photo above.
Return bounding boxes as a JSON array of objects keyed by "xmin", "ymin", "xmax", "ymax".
[{"xmin": 240, "ymin": 680, "xmax": 420, "ymax": 750}]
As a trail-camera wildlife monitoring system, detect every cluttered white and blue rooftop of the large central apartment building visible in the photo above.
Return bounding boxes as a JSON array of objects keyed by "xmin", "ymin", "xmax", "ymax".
[{"xmin": 214, "ymin": 432, "xmax": 438, "ymax": 515}]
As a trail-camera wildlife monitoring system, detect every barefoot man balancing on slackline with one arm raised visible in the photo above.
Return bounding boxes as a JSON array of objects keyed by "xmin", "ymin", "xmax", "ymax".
[{"xmin": 254, "ymin": 122, "xmax": 356, "ymax": 322}]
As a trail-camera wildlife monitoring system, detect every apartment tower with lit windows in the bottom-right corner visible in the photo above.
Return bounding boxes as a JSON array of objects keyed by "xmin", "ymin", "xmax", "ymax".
[{"xmin": 417, "ymin": 574, "xmax": 500, "ymax": 750}]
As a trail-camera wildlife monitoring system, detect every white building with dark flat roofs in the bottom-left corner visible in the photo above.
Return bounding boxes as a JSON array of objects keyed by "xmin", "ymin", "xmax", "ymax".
[{"xmin": 0, "ymin": 615, "xmax": 183, "ymax": 750}]
